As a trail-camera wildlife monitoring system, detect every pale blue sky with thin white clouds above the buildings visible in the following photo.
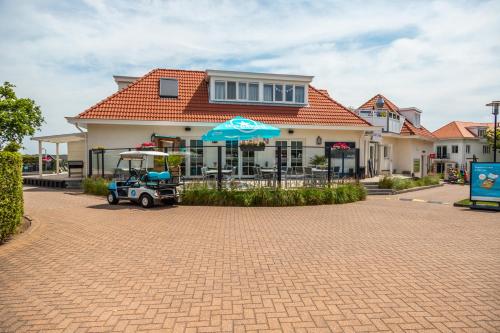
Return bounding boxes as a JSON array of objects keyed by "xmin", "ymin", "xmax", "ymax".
[{"xmin": 0, "ymin": 0, "xmax": 500, "ymax": 152}]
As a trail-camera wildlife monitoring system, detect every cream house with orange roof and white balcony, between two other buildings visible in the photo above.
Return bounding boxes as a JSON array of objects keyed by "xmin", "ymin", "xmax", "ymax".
[{"xmin": 356, "ymin": 94, "xmax": 435, "ymax": 177}]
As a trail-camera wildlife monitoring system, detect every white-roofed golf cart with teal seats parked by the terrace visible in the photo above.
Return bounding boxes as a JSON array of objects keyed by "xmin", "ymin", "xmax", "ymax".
[{"xmin": 108, "ymin": 151, "xmax": 179, "ymax": 208}]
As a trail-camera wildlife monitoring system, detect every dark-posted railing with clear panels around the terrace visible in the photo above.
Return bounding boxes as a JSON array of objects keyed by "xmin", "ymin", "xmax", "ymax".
[{"xmin": 88, "ymin": 142, "xmax": 364, "ymax": 188}]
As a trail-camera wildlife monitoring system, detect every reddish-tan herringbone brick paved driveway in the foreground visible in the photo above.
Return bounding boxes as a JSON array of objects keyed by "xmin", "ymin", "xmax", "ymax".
[{"xmin": 0, "ymin": 187, "xmax": 500, "ymax": 332}]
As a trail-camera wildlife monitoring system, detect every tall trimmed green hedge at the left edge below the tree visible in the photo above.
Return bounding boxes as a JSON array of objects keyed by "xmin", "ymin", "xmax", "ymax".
[{"xmin": 0, "ymin": 151, "xmax": 24, "ymax": 243}]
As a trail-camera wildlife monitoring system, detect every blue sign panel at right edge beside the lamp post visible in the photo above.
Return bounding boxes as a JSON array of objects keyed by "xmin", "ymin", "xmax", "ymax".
[{"xmin": 470, "ymin": 163, "xmax": 500, "ymax": 202}]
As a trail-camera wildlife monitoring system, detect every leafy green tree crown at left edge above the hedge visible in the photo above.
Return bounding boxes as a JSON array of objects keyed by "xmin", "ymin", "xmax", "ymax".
[{"xmin": 0, "ymin": 82, "xmax": 44, "ymax": 149}]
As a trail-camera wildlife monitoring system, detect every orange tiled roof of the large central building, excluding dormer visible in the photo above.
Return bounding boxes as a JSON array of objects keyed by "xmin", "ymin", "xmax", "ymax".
[{"xmin": 77, "ymin": 69, "xmax": 371, "ymax": 127}]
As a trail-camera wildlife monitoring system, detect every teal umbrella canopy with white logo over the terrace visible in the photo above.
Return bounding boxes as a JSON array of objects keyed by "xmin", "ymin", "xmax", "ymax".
[{"xmin": 201, "ymin": 116, "xmax": 280, "ymax": 141}]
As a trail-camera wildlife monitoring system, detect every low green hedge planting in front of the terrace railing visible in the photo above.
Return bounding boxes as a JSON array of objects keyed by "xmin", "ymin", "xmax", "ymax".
[{"xmin": 181, "ymin": 184, "xmax": 366, "ymax": 207}]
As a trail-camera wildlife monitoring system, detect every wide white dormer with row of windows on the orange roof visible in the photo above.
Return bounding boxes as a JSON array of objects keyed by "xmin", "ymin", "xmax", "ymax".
[{"xmin": 206, "ymin": 69, "xmax": 313, "ymax": 107}]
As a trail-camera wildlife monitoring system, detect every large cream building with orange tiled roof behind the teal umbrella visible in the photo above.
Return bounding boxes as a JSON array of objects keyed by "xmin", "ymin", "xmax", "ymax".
[{"xmin": 67, "ymin": 69, "xmax": 380, "ymax": 177}]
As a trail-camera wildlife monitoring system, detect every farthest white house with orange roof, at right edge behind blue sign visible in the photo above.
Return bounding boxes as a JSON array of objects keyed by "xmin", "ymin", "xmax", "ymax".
[{"xmin": 433, "ymin": 121, "xmax": 493, "ymax": 172}]
